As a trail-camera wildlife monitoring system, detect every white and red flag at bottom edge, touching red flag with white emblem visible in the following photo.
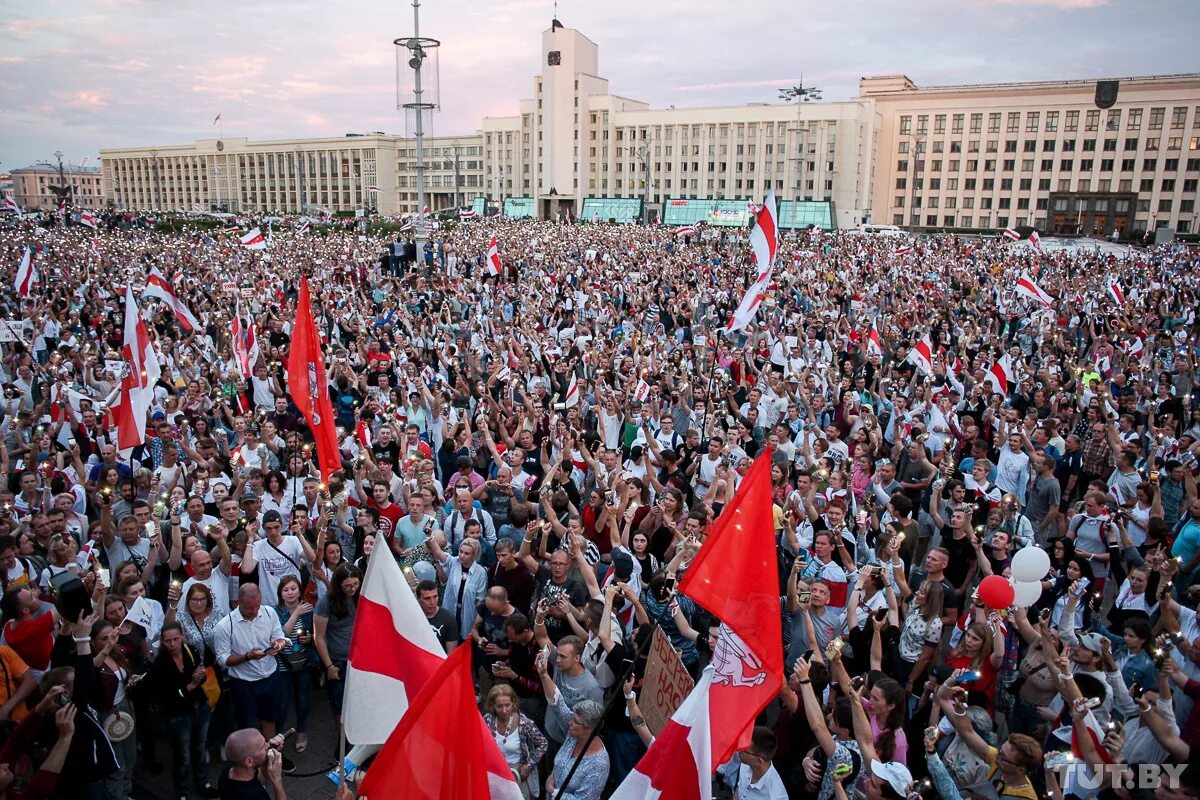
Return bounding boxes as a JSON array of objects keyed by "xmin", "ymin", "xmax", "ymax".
[{"xmin": 612, "ymin": 667, "xmax": 714, "ymax": 800}]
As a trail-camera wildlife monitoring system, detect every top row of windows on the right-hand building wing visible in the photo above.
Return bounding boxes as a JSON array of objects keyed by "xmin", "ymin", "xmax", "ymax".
[{"xmin": 900, "ymin": 106, "xmax": 1200, "ymax": 136}]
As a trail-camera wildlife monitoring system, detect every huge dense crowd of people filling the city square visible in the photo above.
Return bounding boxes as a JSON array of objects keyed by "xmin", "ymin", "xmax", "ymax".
[{"xmin": 0, "ymin": 213, "xmax": 1200, "ymax": 800}]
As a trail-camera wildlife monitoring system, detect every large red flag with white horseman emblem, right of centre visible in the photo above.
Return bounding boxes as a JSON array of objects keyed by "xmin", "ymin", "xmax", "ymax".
[{"xmin": 679, "ymin": 447, "xmax": 784, "ymax": 764}]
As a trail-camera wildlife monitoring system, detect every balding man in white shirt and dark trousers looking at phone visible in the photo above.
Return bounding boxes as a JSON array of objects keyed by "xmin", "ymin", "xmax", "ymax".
[{"xmin": 212, "ymin": 583, "xmax": 288, "ymax": 738}]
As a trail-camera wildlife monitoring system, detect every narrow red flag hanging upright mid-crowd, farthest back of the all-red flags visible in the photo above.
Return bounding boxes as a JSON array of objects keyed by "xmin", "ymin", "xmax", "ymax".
[{"xmin": 288, "ymin": 278, "xmax": 342, "ymax": 481}]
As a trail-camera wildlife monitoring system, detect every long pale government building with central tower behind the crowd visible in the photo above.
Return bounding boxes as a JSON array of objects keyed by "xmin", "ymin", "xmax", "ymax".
[{"xmin": 101, "ymin": 22, "xmax": 1200, "ymax": 235}]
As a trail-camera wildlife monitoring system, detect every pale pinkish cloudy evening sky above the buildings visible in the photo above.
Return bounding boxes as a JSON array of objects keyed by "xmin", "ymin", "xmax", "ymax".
[{"xmin": 0, "ymin": 0, "xmax": 1200, "ymax": 172}]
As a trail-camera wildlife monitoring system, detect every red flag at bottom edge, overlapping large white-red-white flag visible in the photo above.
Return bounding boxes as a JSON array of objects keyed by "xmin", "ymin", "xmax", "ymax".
[{"xmin": 359, "ymin": 642, "xmax": 521, "ymax": 800}]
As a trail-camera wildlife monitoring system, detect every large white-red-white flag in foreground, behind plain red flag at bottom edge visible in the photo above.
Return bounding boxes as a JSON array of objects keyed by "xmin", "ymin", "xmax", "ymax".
[{"xmin": 342, "ymin": 532, "xmax": 460, "ymax": 745}]
